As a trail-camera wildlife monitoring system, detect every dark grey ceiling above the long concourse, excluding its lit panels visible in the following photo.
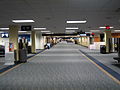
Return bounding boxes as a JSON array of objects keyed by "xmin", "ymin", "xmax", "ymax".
[{"xmin": 0, "ymin": 0, "xmax": 120, "ymax": 33}]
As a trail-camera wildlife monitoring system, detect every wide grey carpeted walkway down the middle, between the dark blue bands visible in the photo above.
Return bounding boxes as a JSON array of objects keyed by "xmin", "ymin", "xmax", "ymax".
[{"xmin": 0, "ymin": 42, "xmax": 120, "ymax": 90}]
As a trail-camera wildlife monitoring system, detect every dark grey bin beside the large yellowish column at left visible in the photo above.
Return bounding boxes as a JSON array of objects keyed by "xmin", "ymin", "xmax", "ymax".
[{"xmin": 19, "ymin": 49, "xmax": 27, "ymax": 63}]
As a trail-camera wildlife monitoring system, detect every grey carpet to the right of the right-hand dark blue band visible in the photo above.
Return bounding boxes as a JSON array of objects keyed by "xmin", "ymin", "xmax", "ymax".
[{"xmin": 80, "ymin": 46, "xmax": 120, "ymax": 74}]
